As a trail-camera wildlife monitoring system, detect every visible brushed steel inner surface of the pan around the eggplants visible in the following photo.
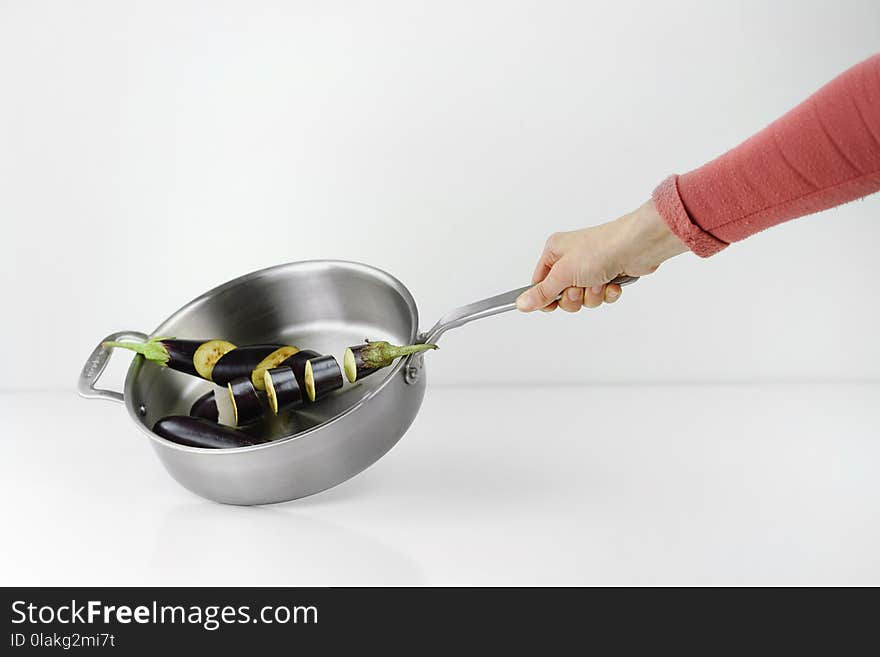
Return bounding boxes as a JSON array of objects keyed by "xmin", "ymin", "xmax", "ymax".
[{"xmin": 126, "ymin": 261, "xmax": 418, "ymax": 439}]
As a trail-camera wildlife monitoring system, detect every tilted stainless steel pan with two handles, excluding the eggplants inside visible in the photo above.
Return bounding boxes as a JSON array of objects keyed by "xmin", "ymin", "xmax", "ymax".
[{"xmin": 78, "ymin": 260, "xmax": 635, "ymax": 504}]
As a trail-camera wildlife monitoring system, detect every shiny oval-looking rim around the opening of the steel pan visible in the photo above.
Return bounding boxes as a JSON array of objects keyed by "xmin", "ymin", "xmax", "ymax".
[{"xmin": 124, "ymin": 259, "xmax": 419, "ymax": 457}]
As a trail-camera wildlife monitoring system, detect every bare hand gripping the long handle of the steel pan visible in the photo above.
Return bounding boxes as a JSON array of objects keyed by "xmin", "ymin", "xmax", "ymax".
[{"xmin": 516, "ymin": 201, "xmax": 688, "ymax": 313}]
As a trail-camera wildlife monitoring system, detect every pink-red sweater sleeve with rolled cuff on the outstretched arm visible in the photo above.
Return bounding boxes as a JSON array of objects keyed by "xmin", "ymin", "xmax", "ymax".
[{"xmin": 654, "ymin": 54, "xmax": 880, "ymax": 257}]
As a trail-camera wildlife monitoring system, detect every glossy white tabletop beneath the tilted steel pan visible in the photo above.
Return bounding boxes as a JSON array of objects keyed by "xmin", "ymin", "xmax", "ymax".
[{"xmin": 0, "ymin": 384, "xmax": 880, "ymax": 585}]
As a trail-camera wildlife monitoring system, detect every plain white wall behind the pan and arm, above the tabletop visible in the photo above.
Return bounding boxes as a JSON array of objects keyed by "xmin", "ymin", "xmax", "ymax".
[{"xmin": 0, "ymin": 0, "xmax": 880, "ymax": 389}]
